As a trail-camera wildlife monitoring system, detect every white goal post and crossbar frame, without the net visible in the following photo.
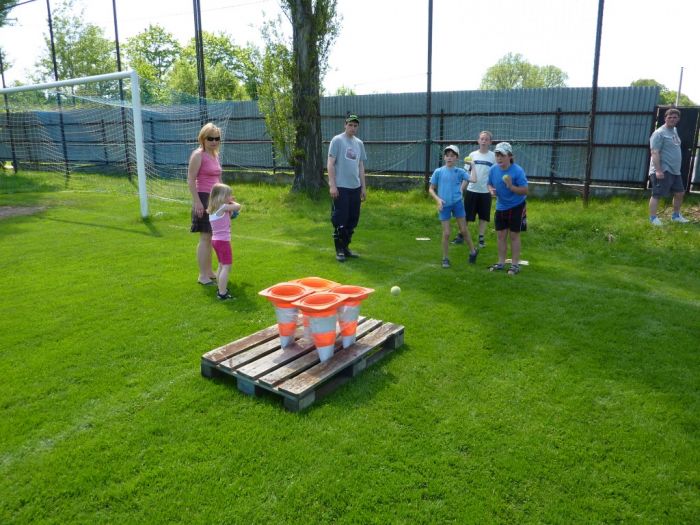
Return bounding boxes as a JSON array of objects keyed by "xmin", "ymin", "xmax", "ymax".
[{"xmin": 0, "ymin": 71, "xmax": 148, "ymax": 218}]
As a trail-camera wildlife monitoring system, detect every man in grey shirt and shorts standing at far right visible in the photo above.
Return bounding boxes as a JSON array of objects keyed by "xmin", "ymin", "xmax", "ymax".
[{"xmin": 649, "ymin": 108, "xmax": 690, "ymax": 226}]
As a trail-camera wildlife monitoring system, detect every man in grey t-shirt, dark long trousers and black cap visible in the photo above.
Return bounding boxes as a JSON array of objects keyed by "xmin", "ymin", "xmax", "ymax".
[{"xmin": 327, "ymin": 115, "xmax": 367, "ymax": 262}]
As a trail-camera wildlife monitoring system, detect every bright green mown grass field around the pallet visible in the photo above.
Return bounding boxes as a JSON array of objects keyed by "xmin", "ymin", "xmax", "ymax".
[{"xmin": 0, "ymin": 175, "xmax": 700, "ymax": 524}]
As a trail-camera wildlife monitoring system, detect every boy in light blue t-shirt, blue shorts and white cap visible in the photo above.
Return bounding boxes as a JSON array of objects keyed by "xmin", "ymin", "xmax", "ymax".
[{"xmin": 428, "ymin": 142, "xmax": 479, "ymax": 268}]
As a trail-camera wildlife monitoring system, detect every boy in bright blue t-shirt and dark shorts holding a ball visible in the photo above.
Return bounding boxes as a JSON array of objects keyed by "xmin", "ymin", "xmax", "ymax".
[{"xmin": 488, "ymin": 142, "xmax": 527, "ymax": 275}]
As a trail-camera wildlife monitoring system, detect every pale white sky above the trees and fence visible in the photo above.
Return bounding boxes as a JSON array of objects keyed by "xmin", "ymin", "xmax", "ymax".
[{"xmin": 0, "ymin": 0, "xmax": 700, "ymax": 104}]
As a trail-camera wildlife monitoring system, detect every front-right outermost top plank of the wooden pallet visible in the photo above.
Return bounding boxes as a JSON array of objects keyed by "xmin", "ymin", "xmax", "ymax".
[{"xmin": 277, "ymin": 323, "xmax": 404, "ymax": 398}]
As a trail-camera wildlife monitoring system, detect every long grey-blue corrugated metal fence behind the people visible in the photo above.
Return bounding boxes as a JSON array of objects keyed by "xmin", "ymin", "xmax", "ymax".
[{"xmin": 0, "ymin": 87, "xmax": 680, "ymax": 187}]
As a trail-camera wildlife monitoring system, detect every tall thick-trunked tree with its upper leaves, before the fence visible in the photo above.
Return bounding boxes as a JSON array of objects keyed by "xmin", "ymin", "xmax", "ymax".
[{"xmin": 282, "ymin": 0, "xmax": 338, "ymax": 194}]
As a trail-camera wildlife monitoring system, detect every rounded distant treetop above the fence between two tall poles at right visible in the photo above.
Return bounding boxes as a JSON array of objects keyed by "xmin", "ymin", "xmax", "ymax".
[{"xmin": 481, "ymin": 53, "xmax": 569, "ymax": 89}]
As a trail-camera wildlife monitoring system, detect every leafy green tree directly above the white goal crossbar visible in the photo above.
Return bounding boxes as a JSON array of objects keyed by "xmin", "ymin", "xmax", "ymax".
[{"xmin": 33, "ymin": 0, "xmax": 116, "ymax": 88}]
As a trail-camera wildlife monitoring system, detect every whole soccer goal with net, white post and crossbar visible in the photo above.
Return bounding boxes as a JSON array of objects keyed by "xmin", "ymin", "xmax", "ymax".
[{"xmin": 0, "ymin": 72, "xmax": 232, "ymax": 217}]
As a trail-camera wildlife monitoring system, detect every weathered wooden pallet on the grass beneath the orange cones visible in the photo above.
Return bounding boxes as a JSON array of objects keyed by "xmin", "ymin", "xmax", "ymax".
[{"xmin": 201, "ymin": 317, "xmax": 404, "ymax": 412}]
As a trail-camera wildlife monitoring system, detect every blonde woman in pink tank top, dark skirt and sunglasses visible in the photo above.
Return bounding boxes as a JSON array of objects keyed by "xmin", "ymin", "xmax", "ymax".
[{"xmin": 187, "ymin": 122, "xmax": 221, "ymax": 285}]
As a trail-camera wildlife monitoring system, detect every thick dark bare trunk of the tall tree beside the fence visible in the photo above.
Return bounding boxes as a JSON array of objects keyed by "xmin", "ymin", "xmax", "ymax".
[{"xmin": 289, "ymin": 0, "xmax": 327, "ymax": 194}]
